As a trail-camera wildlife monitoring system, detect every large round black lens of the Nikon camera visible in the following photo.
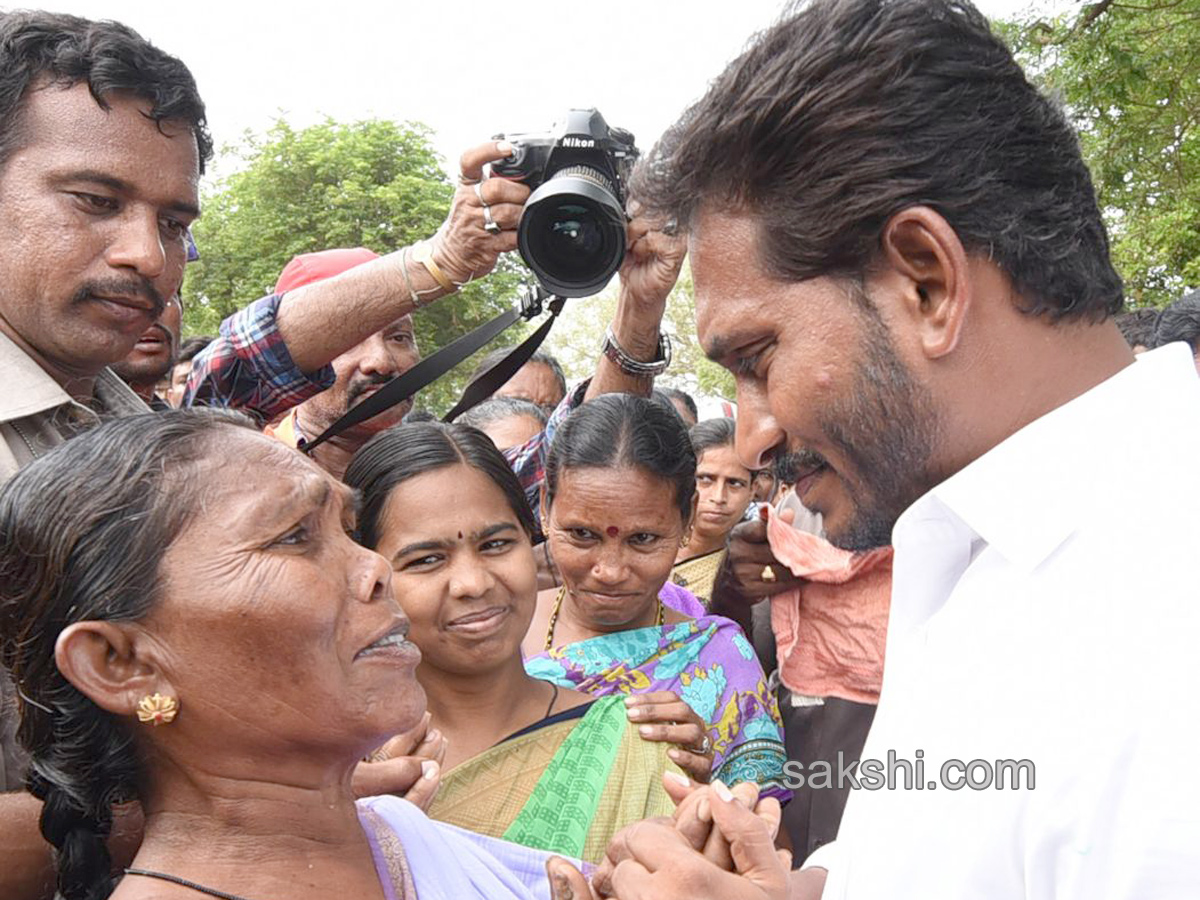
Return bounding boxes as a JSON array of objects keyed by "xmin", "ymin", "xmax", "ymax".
[{"xmin": 517, "ymin": 166, "xmax": 625, "ymax": 296}]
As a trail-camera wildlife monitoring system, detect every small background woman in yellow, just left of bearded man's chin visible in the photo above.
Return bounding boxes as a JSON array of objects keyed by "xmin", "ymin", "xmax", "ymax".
[{"xmin": 671, "ymin": 419, "xmax": 755, "ymax": 608}]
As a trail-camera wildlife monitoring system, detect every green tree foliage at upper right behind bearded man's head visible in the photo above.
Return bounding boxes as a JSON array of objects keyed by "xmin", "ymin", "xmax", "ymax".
[{"xmin": 1002, "ymin": 0, "xmax": 1200, "ymax": 306}]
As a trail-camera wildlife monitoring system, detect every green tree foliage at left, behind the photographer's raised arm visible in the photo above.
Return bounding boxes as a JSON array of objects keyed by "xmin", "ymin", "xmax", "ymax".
[{"xmin": 184, "ymin": 120, "xmax": 522, "ymax": 412}]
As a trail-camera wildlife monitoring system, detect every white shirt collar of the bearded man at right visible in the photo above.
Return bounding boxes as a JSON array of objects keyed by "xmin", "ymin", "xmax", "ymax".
[{"xmin": 896, "ymin": 346, "xmax": 1200, "ymax": 570}]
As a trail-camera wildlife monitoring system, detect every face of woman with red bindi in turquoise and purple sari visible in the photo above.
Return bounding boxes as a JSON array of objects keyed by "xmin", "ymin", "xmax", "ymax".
[{"xmin": 548, "ymin": 468, "xmax": 685, "ymax": 631}]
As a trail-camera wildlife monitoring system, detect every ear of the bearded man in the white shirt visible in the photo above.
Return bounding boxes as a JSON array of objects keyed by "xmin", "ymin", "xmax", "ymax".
[{"xmin": 881, "ymin": 206, "xmax": 972, "ymax": 359}]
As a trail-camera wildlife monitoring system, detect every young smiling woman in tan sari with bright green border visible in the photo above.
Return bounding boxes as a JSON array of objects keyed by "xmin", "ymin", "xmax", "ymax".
[{"xmin": 346, "ymin": 422, "xmax": 691, "ymax": 862}]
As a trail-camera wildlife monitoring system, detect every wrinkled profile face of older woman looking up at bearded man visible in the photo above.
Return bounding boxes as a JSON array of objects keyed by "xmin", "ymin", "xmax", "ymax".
[{"xmin": 142, "ymin": 428, "xmax": 425, "ymax": 775}]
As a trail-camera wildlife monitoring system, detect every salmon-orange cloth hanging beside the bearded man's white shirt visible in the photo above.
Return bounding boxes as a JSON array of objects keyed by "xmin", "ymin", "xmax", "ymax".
[{"xmin": 767, "ymin": 509, "xmax": 893, "ymax": 703}]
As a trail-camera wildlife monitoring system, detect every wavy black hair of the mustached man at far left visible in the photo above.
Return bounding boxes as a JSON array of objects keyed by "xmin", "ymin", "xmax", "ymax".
[{"xmin": 0, "ymin": 11, "xmax": 212, "ymax": 173}]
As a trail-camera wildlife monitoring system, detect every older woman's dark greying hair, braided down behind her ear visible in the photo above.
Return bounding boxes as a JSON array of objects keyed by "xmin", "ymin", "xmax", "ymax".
[{"xmin": 0, "ymin": 410, "xmax": 250, "ymax": 900}]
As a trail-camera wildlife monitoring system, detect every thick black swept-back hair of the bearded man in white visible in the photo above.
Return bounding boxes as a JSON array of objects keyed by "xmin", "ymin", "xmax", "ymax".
[{"xmin": 631, "ymin": 0, "xmax": 1122, "ymax": 320}]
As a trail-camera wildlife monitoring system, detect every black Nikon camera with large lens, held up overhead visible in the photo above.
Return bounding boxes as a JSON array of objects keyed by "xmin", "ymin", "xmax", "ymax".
[{"xmin": 492, "ymin": 109, "xmax": 637, "ymax": 296}]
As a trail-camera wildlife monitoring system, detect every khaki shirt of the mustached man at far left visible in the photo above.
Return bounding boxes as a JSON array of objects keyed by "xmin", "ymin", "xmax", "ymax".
[{"xmin": 0, "ymin": 334, "xmax": 148, "ymax": 791}]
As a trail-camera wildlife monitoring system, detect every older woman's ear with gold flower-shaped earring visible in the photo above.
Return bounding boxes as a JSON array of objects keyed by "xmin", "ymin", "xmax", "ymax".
[{"xmin": 54, "ymin": 622, "xmax": 174, "ymax": 716}]
